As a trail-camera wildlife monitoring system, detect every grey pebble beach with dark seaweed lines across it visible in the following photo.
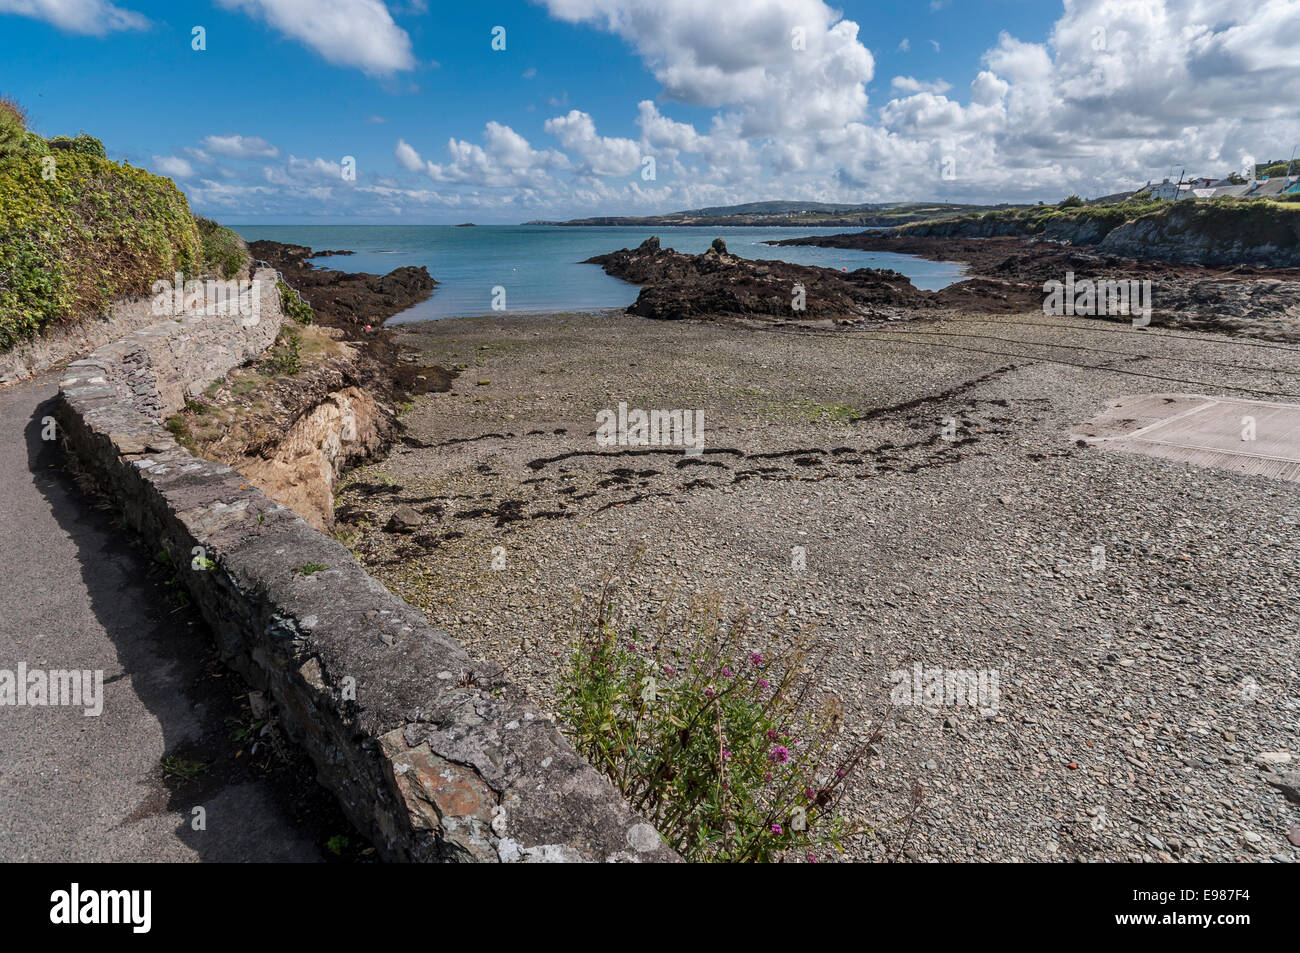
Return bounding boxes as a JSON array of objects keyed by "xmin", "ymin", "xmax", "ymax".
[{"xmin": 337, "ymin": 306, "xmax": 1300, "ymax": 862}]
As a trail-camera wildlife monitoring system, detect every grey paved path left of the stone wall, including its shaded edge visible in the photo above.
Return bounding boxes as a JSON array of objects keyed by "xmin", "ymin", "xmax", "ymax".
[{"xmin": 0, "ymin": 374, "xmax": 321, "ymax": 861}]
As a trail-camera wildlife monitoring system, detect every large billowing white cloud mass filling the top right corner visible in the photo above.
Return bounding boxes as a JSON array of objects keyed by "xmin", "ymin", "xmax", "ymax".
[{"xmin": 852, "ymin": 0, "xmax": 1300, "ymax": 199}]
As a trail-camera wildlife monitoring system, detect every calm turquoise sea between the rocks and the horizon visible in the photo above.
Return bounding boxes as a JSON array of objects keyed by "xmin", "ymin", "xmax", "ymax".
[{"xmin": 233, "ymin": 225, "xmax": 965, "ymax": 324}]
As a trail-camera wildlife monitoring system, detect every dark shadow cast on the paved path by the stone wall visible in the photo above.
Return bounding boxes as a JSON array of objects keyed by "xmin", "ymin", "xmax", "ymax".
[{"xmin": 25, "ymin": 395, "xmax": 373, "ymax": 862}]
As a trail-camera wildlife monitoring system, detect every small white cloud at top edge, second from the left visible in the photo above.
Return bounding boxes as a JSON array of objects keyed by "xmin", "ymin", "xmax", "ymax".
[{"xmin": 217, "ymin": 0, "xmax": 416, "ymax": 75}]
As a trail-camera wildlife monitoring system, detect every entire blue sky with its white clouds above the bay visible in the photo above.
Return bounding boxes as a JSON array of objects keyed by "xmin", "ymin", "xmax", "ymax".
[{"xmin": 0, "ymin": 0, "xmax": 1300, "ymax": 222}]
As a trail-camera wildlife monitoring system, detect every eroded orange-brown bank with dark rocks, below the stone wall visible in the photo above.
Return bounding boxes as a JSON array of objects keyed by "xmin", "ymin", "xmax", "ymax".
[{"xmin": 168, "ymin": 242, "xmax": 454, "ymax": 530}]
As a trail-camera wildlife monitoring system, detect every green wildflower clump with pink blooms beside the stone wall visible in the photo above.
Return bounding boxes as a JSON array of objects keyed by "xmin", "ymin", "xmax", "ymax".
[{"xmin": 560, "ymin": 564, "xmax": 879, "ymax": 862}]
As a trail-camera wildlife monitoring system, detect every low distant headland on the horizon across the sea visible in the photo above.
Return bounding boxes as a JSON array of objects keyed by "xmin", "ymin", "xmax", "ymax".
[{"xmin": 524, "ymin": 202, "xmax": 1026, "ymax": 228}]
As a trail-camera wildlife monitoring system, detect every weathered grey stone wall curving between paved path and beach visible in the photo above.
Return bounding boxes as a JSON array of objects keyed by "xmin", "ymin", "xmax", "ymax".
[{"xmin": 59, "ymin": 273, "xmax": 677, "ymax": 862}]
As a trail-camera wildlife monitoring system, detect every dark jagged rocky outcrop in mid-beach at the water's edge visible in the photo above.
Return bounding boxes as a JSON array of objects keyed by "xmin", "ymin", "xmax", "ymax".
[{"xmin": 586, "ymin": 238, "xmax": 932, "ymax": 322}]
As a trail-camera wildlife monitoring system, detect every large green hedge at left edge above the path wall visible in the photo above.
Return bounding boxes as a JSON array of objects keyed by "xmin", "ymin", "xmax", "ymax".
[{"xmin": 0, "ymin": 151, "xmax": 203, "ymax": 348}]
